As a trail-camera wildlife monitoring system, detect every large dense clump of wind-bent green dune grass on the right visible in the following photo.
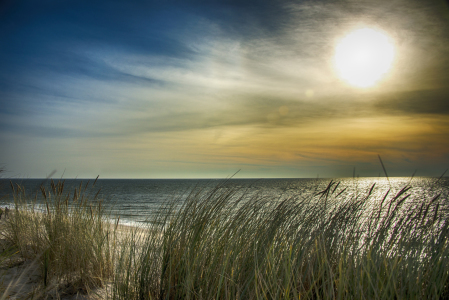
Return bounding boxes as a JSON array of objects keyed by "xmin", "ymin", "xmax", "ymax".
[{"xmin": 111, "ymin": 182, "xmax": 449, "ymax": 299}]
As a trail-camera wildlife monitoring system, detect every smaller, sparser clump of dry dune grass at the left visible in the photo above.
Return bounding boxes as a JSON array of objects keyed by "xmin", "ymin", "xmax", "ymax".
[{"xmin": 3, "ymin": 180, "xmax": 115, "ymax": 293}]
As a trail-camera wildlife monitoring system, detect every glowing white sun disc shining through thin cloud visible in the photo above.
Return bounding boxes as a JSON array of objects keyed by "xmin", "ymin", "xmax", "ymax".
[{"xmin": 335, "ymin": 28, "xmax": 394, "ymax": 88}]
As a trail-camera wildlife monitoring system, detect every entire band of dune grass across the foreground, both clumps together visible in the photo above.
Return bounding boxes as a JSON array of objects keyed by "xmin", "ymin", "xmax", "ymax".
[{"xmin": 1, "ymin": 179, "xmax": 449, "ymax": 299}]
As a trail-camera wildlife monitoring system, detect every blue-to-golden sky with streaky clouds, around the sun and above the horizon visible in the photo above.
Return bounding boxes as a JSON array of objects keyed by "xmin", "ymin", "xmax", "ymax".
[{"xmin": 0, "ymin": 0, "xmax": 449, "ymax": 178}]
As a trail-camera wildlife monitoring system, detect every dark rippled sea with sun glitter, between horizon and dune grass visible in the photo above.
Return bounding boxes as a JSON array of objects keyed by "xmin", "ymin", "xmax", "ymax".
[{"xmin": 0, "ymin": 177, "xmax": 449, "ymax": 225}]
